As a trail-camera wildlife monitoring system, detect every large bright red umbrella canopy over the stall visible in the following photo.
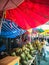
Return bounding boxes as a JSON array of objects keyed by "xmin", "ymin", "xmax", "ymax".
[{"xmin": 6, "ymin": 0, "xmax": 49, "ymax": 30}]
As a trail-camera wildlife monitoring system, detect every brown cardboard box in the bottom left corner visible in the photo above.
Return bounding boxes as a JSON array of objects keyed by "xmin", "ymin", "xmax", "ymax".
[{"xmin": 0, "ymin": 56, "xmax": 20, "ymax": 65}]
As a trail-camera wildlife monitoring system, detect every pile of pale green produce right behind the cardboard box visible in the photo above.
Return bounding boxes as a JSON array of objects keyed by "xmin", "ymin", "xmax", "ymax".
[{"xmin": 11, "ymin": 43, "xmax": 36, "ymax": 65}]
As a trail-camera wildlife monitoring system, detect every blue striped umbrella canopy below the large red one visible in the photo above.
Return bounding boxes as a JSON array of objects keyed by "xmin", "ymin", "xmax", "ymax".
[{"xmin": 0, "ymin": 20, "xmax": 26, "ymax": 38}]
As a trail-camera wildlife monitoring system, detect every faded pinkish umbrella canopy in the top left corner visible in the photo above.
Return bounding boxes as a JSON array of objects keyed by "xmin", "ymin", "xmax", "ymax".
[{"xmin": 0, "ymin": 0, "xmax": 24, "ymax": 11}]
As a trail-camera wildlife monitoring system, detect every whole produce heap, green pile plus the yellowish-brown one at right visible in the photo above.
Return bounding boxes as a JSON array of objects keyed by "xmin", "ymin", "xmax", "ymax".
[{"xmin": 11, "ymin": 40, "xmax": 42, "ymax": 65}]
